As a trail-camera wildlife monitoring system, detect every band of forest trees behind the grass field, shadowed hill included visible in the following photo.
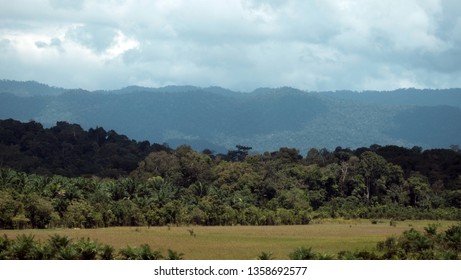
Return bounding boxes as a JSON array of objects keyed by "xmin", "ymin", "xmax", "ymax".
[{"xmin": 0, "ymin": 120, "xmax": 461, "ymax": 228}]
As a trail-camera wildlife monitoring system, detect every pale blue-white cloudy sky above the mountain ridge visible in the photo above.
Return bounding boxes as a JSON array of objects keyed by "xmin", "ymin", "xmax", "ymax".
[{"xmin": 0, "ymin": 0, "xmax": 461, "ymax": 91}]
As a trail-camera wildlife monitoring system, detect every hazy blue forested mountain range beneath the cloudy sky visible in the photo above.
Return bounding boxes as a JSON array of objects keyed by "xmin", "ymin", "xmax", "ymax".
[{"xmin": 0, "ymin": 80, "xmax": 461, "ymax": 152}]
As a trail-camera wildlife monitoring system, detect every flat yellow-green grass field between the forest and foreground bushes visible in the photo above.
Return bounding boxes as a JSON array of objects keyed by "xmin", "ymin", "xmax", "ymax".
[{"xmin": 0, "ymin": 220, "xmax": 457, "ymax": 260}]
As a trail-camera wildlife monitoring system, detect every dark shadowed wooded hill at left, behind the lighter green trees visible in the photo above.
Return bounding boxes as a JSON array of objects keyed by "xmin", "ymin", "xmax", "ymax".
[{"xmin": 0, "ymin": 119, "xmax": 169, "ymax": 177}]
